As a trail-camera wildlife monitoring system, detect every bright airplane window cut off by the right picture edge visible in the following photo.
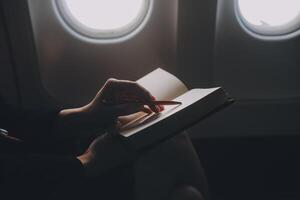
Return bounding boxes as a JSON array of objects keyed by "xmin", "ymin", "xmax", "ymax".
[{"xmin": 236, "ymin": 0, "xmax": 300, "ymax": 36}]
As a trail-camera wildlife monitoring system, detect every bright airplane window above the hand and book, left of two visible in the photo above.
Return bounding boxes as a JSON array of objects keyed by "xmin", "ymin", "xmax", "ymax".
[{"xmin": 56, "ymin": 0, "xmax": 151, "ymax": 38}]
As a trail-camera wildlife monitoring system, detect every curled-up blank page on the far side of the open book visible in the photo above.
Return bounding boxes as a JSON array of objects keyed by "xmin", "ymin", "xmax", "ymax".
[{"xmin": 137, "ymin": 68, "xmax": 188, "ymax": 100}]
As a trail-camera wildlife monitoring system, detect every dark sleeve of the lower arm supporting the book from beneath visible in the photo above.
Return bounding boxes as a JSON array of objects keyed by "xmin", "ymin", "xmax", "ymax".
[{"xmin": 0, "ymin": 131, "xmax": 84, "ymax": 199}]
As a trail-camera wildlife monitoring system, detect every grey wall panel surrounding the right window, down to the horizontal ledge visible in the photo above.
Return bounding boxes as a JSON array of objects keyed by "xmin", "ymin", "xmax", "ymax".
[{"xmin": 214, "ymin": 0, "xmax": 300, "ymax": 101}]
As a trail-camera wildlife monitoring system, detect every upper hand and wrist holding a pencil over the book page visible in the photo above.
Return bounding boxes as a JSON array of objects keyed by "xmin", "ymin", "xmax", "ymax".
[{"xmin": 56, "ymin": 79, "xmax": 163, "ymax": 137}]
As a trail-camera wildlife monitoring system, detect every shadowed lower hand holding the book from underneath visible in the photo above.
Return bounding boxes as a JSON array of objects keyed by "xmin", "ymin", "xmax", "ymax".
[{"xmin": 77, "ymin": 134, "xmax": 135, "ymax": 177}]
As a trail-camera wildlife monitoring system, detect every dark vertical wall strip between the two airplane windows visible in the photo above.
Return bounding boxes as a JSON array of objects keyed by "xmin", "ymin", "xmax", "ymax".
[{"xmin": 178, "ymin": 0, "xmax": 217, "ymax": 88}]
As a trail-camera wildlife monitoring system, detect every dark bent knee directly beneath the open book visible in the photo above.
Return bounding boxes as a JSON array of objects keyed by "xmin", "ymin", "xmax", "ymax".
[{"xmin": 135, "ymin": 134, "xmax": 207, "ymax": 200}]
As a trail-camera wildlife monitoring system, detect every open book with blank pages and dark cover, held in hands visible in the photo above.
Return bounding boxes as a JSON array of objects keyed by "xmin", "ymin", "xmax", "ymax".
[{"xmin": 120, "ymin": 68, "xmax": 230, "ymax": 149}]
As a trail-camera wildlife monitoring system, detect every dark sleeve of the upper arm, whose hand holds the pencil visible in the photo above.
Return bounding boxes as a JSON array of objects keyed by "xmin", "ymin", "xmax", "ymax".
[{"xmin": 0, "ymin": 96, "xmax": 59, "ymax": 140}]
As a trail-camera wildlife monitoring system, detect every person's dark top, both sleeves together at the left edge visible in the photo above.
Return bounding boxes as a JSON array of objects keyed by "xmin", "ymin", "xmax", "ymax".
[{"xmin": 0, "ymin": 96, "xmax": 83, "ymax": 199}]
